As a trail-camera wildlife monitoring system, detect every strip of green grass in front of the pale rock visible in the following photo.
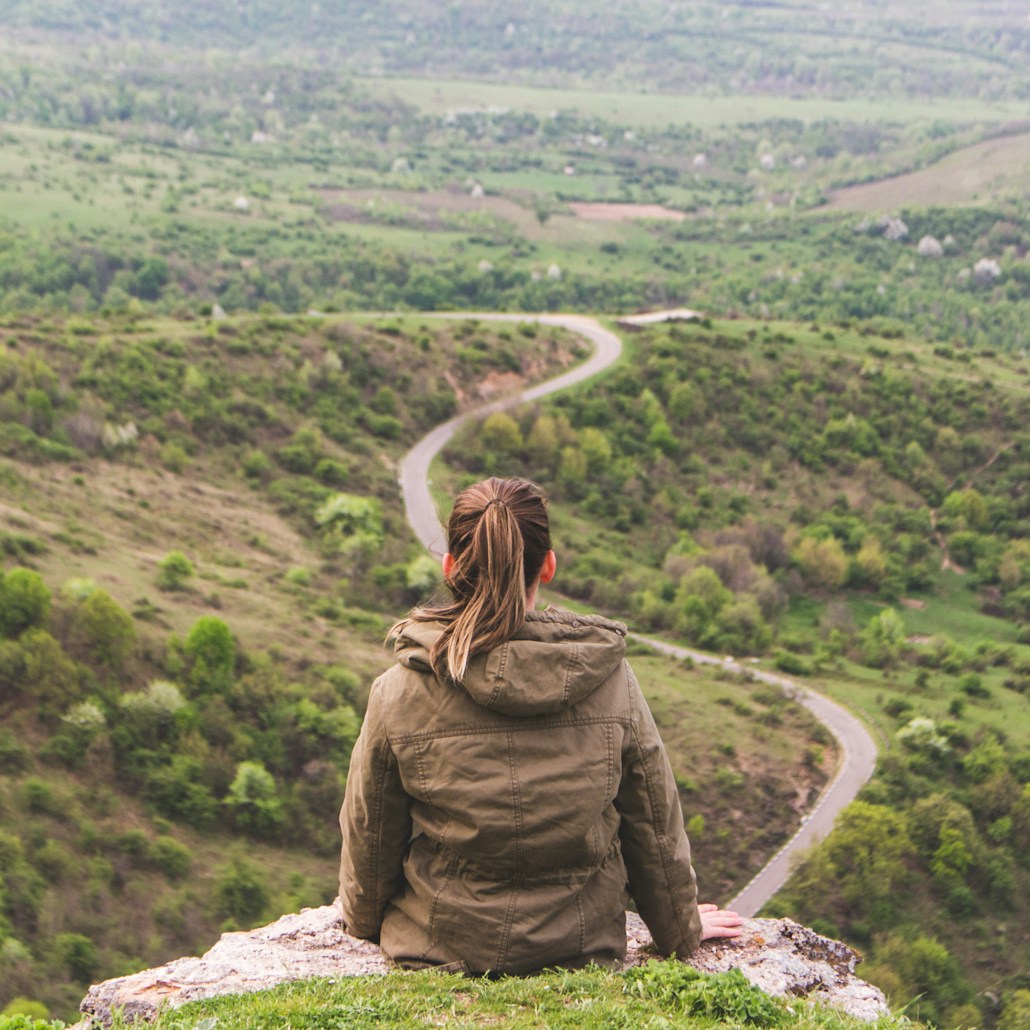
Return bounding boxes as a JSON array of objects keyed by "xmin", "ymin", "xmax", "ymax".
[{"xmin": 100, "ymin": 961, "xmax": 912, "ymax": 1030}]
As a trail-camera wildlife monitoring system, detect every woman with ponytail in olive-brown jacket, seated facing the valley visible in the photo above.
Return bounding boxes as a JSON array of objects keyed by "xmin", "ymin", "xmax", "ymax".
[{"xmin": 340, "ymin": 479, "xmax": 741, "ymax": 974}]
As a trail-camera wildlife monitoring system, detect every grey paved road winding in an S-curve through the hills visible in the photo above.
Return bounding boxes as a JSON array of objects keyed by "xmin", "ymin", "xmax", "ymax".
[{"xmin": 399, "ymin": 313, "xmax": 877, "ymax": 916}]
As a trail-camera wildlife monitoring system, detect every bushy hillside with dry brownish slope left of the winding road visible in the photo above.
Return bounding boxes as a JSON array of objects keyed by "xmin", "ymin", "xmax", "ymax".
[{"xmin": 0, "ymin": 315, "xmax": 835, "ymax": 1016}]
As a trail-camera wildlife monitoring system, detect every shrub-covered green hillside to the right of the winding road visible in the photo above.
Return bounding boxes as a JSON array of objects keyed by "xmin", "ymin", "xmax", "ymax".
[{"xmin": 445, "ymin": 321, "xmax": 1030, "ymax": 1026}]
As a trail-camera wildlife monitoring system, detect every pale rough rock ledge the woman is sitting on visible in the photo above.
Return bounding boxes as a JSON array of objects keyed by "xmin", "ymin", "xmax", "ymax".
[{"xmin": 72, "ymin": 905, "xmax": 888, "ymax": 1030}]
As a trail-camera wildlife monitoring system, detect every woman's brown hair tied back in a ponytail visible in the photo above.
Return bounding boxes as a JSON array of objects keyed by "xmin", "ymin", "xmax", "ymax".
[{"xmin": 390, "ymin": 478, "xmax": 551, "ymax": 683}]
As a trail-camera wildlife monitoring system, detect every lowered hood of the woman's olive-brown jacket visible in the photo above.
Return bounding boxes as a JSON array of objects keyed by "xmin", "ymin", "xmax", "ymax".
[{"xmin": 393, "ymin": 608, "xmax": 626, "ymax": 716}]
